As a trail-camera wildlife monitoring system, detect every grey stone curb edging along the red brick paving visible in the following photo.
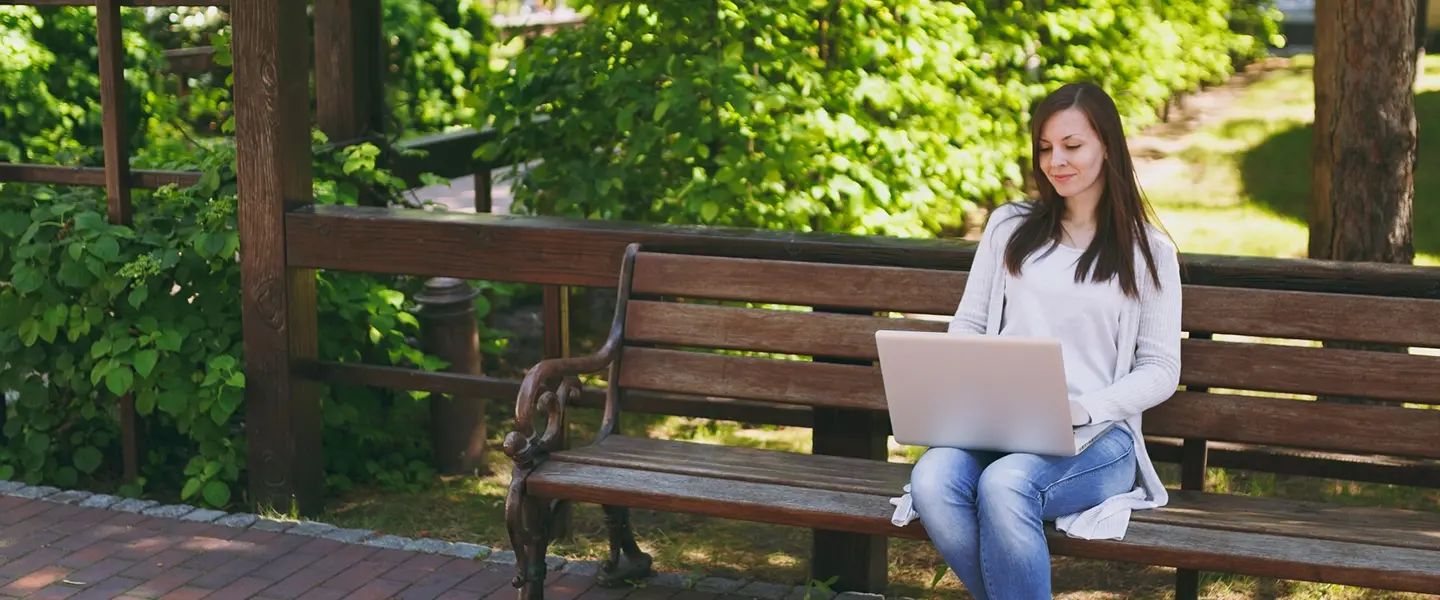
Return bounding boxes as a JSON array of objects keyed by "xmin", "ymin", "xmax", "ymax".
[{"xmin": 0, "ymin": 479, "xmax": 884, "ymax": 600}]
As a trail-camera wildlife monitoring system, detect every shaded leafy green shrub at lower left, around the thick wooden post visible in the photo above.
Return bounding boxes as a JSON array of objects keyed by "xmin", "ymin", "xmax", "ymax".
[{"xmin": 0, "ymin": 130, "xmax": 460, "ymax": 506}]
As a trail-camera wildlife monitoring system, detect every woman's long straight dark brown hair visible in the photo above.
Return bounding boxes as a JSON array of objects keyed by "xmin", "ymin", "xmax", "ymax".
[{"xmin": 1005, "ymin": 83, "xmax": 1159, "ymax": 298}]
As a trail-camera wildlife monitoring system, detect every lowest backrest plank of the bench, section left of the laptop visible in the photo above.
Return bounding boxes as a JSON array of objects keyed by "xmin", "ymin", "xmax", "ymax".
[{"xmin": 619, "ymin": 347, "xmax": 886, "ymax": 410}]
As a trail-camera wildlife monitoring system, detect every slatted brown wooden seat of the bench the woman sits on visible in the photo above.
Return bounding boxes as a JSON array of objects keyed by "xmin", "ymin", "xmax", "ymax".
[{"xmin": 526, "ymin": 440, "xmax": 1440, "ymax": 593}]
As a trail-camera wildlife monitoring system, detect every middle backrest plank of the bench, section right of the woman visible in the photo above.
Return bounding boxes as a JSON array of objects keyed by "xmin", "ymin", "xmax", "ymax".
[{"xmin": 1181, "ymin": 340, "xmax": 1440, "ymax": 404}]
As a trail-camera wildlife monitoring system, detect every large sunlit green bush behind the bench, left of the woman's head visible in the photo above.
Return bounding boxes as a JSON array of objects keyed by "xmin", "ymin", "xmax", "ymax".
[{"xmin": 478, "ymin": 0, "xmax": 1278, "ymax": 236}]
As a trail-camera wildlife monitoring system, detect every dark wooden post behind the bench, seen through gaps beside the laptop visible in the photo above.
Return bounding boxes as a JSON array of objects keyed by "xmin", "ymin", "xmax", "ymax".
[{"xmin": 811, "ymin": 306, "xmax": 890, "ymax": 594}]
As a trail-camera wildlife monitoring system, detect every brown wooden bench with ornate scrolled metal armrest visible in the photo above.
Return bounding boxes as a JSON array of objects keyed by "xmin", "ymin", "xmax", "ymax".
[{"xmin": 505, "ymin": 246, "xmax": 1440, "ymax": 599}]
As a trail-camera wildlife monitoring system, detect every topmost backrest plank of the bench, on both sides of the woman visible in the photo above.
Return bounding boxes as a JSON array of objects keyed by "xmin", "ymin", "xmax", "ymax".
[{"xmin": 632, "ymin": 252, "xmax": 1440, "ymax": 348}]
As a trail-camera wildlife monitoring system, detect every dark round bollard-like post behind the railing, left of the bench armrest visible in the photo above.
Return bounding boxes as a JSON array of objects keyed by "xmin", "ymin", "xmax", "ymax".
[{"xmin": 415, "ymin": 278, "xmax": 490, "ymax": 475}]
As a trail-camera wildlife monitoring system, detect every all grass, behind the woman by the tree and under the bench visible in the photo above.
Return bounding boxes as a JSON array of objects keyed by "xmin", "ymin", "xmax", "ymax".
[{"xmin": 321, "ymin": 56, "xmax": 1440, "ymax": 600}]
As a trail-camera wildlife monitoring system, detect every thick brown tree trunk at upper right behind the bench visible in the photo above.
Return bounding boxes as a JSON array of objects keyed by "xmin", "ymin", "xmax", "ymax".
[{"xmin": 1309, "ymin": 0, "xmax": 1420, "ymax": 263}]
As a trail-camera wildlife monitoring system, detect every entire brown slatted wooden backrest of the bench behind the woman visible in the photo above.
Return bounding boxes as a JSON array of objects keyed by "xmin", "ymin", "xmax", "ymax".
[{"xmin": 618, "ymin": 252, "xmax": 1440, "ymax": 469}]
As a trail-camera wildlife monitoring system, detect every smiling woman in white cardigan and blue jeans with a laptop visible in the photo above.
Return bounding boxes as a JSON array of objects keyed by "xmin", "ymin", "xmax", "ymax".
[{"xmin": 910, "ymin": 83, "xmax": 1181, "ymax": 600}]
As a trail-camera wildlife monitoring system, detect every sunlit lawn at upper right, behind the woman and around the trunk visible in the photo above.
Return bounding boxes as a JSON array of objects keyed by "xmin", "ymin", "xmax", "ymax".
[{"xmin": 1142, "ymin": 56, "xmax": 1440, "ymax": 265}]
